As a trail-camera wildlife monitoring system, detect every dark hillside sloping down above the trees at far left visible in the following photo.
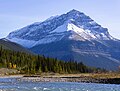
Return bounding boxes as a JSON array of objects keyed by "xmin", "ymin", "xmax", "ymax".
[{"xmin": 0, "ymin": 39, "xmax": 32, "ymax": 53}]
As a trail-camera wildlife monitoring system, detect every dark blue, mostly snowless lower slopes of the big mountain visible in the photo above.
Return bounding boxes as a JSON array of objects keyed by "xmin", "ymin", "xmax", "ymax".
[{"xmin": 30, "ymin": 40, "xmax": 120, "ymax": 70}]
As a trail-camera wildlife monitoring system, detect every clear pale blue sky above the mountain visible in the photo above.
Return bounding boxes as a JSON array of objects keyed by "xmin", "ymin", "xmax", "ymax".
[{"xmin": 0, "ymin": 0, "xmax": 120, "ymax": 39}]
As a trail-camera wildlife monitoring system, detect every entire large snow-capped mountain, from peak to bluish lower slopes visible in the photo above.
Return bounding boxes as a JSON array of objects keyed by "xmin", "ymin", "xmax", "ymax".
[{"xmin": 7, "ymin": 10, "xmax": 120, "ymax": 69}]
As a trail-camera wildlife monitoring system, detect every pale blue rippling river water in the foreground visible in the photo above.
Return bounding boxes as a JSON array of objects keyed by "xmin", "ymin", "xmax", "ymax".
[{"xmin": 0, "ymin": 78, "xmax": 120, "ymax": 91}]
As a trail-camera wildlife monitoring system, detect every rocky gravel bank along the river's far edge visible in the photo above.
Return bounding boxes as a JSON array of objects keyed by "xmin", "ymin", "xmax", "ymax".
[{"xmin": 17, "ymin": 76, "xmax": 120, "ymax": 84}]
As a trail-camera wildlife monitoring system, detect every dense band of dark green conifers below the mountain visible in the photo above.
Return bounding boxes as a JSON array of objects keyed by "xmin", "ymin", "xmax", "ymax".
[{"xmin": 0, "ymin": 46, "xmax": 104, "ymax": 74}]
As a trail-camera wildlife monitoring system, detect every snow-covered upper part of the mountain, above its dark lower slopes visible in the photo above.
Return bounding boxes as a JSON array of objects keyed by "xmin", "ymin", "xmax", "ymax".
[{"xmin": 7, "ymin": 10, "xmax": 113, "ymax": 48}]
